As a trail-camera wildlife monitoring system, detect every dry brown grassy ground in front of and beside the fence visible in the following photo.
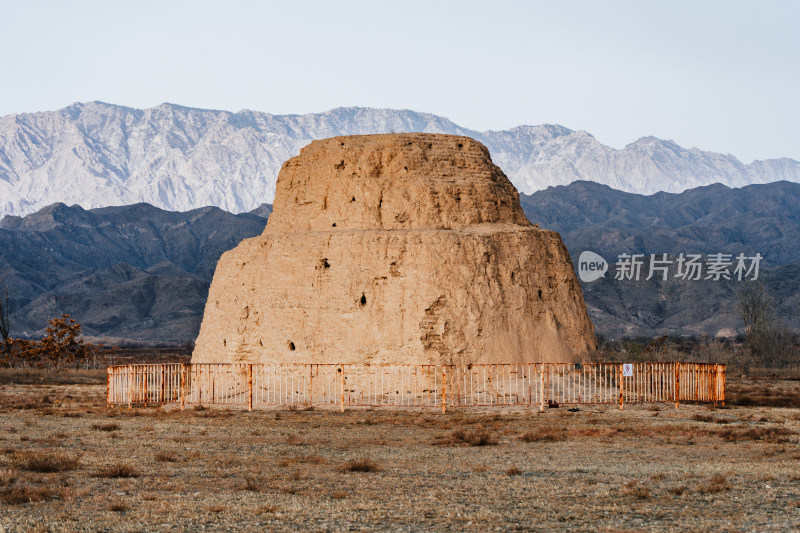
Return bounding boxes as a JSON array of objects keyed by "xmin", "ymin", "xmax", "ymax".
[{"xmin": 0, "ymin": 372, "xmax": 800, "ymax": 532}]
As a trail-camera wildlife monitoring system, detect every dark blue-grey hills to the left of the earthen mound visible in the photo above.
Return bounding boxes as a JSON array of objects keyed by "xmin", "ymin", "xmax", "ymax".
[{"xmin": 0, "ymin": 204, "xmax": 270, "ymax": 341}]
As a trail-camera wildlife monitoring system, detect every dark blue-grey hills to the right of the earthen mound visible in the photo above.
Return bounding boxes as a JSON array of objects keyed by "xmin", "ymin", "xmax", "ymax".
[{"xmin": 521, "ymin": 182, "xmax": 800, "ymax": 337}]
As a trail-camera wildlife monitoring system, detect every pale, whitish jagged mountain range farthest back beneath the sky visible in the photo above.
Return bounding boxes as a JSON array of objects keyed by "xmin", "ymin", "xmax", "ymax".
[{"xmin": 0, "ymin": 102, "xmax": 800, "ymax": 216}]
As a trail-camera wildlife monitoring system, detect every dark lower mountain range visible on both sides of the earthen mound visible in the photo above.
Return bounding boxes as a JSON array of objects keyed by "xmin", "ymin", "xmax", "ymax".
[{"xmin": 0, "ymin": 181, "xmax": 800, "ymax": 342}]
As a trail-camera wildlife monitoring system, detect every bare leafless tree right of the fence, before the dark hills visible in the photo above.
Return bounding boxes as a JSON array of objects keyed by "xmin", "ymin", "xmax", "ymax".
[{"xmin": 737, "ymin": 281, "xmax": 793, "ymax": 366}]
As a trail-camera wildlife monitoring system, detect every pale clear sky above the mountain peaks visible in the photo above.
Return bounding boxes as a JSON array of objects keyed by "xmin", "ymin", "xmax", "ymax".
[{"xmin": 0, "ymin": 0, "xmax": 800, "ymax": 162}]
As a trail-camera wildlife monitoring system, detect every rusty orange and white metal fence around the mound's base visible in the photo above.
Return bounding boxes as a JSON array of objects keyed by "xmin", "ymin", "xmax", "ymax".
[{"xmin": 107, "ymin": 363, "xmax": 725, "ymax": 412}]
